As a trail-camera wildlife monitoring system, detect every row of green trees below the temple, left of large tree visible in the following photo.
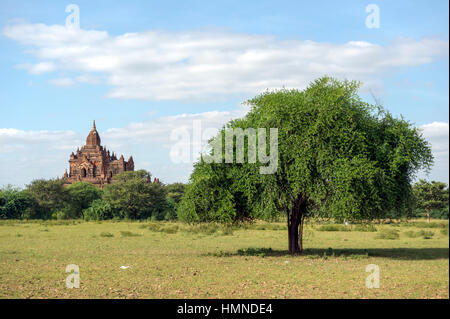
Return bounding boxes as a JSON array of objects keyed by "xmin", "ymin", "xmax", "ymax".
[{"xmin": 0, "ymin": 170, "xmax": 184, "ymax": 220}]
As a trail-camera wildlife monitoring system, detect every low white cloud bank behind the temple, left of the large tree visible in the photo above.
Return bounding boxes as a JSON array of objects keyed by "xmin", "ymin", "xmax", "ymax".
[{"xmin": 0, "ymin": 106, "xmax": 247, "ymax": 187}]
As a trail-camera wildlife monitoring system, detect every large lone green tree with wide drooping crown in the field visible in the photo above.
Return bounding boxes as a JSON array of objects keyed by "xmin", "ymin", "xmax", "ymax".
[{"xmin": 178, "ymin": 77, "xmax": 433, "ymax": 253}]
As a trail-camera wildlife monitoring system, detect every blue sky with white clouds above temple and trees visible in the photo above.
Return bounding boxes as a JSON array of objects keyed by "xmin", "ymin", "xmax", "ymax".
[{"xmin": 0, "ymin": 0, "xmax": 449, "ymax": 187}]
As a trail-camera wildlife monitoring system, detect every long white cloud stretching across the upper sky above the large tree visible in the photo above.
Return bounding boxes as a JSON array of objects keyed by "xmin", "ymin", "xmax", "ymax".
[{"xmin": 3, "ymin": 23, "xmax": 448, "ymax": 100}]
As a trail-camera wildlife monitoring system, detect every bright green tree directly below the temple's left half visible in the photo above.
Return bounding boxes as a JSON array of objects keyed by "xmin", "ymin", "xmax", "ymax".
[{"xmin": 65, "ymin": 182, "xmax": 102, "ymax": 218}]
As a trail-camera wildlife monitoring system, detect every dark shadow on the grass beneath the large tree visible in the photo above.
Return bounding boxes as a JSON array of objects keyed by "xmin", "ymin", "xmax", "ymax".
[{"xmin": 208, "ymin": 248, "xmax": 449, "ymax": 260}]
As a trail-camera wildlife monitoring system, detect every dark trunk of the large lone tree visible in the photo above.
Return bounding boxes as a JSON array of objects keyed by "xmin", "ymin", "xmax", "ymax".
[{"xmin": 288, "ymin": 198, "xmax": 306, "ymax": 254}]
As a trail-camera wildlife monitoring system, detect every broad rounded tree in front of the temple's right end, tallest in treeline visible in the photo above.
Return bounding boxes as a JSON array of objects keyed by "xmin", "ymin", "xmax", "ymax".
[{"xmin": 103, "ymin": 170, "xmax": 166, "ymax": 219}]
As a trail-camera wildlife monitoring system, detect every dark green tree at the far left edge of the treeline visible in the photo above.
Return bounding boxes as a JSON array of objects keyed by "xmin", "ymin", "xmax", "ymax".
[{"xmin": 0, "ymin": 186, "xmax": 33, "ymax": 219}]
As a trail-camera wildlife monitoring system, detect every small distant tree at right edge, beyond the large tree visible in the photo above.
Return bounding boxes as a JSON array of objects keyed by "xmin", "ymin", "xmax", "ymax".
[{"xmin": 413, "ymin": 179, "xmax": 448, "ymax": 222}]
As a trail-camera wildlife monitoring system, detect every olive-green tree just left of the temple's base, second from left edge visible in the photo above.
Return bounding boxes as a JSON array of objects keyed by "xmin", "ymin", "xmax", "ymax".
[{"xmin": 25, "ymin": 179, "xmax": 67, "ymax": 219}]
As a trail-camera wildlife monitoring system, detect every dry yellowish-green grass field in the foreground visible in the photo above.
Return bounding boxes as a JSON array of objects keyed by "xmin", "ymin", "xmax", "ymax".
[{"xmin": 0, "ymin": 220, "xmax": 449, "ymax": 298}]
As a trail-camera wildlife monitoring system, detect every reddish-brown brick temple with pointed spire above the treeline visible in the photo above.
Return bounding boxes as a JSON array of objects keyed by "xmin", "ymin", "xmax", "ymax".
[{"xmin": 63, "ymin": 121, "xmax": 134, "ymax": 188}]
